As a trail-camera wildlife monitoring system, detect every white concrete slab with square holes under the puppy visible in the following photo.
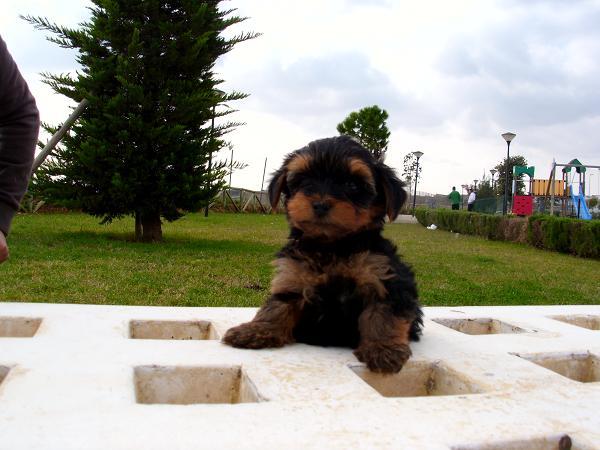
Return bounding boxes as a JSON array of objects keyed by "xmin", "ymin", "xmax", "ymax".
[{"xmin": 0, "ymin": 303, "xmax": 600, "ymax": 450}]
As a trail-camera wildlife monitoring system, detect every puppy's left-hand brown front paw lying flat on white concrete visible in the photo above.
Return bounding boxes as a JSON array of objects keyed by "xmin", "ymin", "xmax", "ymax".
[{"xmin": 223, "ymin": 322, "xmax": 291, "ymax": 349}]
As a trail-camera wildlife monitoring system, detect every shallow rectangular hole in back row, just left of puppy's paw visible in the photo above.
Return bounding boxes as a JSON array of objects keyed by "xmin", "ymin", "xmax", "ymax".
[{"xmin": 129, "ymin": 320, "xmax": 218, "ymax": 340}]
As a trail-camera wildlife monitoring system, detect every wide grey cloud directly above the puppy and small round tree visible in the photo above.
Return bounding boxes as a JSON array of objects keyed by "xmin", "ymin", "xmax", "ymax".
[{"xmin": 227, "ymin": 52, "xmax": 439, "ymax": 134}]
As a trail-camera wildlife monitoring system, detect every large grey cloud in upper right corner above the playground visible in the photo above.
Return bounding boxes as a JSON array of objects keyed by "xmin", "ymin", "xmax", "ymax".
[{"xmin": 436, "ymin": 2, "xmax": 600, "ymax": 131}]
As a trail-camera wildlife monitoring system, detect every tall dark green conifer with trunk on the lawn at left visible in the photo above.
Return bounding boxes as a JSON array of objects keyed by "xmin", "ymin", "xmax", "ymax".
[{"xmin": 24, "ymin": 0, "xmax": 257, "ymax": 241}]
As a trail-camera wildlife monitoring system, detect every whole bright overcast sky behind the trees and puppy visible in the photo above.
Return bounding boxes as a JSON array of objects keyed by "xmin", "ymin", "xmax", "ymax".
[{"xmin": 0, "ymin": 0, "xmax": 600, "ymax": 193}]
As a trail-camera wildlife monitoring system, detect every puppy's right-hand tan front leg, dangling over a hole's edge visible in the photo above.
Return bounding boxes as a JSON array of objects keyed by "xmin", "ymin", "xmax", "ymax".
[{"xmin": 354, "ymin": 301, "xmax": 412, "ymax": 373}]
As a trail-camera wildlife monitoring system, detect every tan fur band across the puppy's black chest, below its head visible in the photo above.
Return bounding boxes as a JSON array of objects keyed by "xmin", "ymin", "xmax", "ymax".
[{"xmin": 271, "ymin": 252, "xmax": 395, "ymax": 301}]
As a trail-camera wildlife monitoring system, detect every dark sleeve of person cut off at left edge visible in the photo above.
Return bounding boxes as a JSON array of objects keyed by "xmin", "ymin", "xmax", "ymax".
[{"xmin": 0, "ymin": 37, "xmax": 40, "ymax": 236}]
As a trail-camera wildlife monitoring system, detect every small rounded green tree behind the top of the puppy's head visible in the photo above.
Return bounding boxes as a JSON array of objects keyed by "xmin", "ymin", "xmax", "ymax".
[{"xmin": 337, "ymin": 105, "xmax": 390, "ymax": 161}]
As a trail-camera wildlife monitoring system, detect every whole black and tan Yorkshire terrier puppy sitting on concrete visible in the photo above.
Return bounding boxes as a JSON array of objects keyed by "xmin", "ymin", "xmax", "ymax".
[{"xmin": 223, "ymin": 136, "xmax": 423, "ymax": 372}]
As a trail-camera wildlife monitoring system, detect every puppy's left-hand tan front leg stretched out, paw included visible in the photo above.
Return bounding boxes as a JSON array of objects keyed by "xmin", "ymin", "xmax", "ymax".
[{"xmin": 223, "ymin": 295, "xmax": 301, "ymax": 349}]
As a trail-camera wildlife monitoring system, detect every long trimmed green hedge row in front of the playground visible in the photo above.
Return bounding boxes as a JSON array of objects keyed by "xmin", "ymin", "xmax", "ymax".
[{"xmin": 415, "ymin": 208, "xmax": 600, "ymax": 258}]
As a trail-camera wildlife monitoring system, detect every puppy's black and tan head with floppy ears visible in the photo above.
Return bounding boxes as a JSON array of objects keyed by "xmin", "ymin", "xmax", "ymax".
[{"xmin": 269, "ymin": 136, "xmax": 406, "ymax": 240}]
